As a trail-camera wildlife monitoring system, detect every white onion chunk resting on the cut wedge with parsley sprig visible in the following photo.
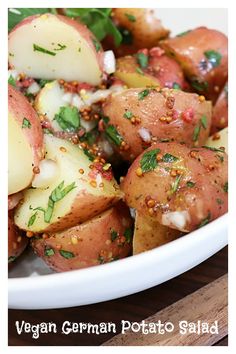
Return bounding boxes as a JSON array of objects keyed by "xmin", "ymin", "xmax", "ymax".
[{"xmin": 32, "ymin": 159, "xmax": 59, "ymax": 188}]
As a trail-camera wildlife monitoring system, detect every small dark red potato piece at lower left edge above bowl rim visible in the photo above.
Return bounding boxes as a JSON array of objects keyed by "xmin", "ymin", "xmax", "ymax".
[{"xmin": 8, "ymin": 212, "xmax": 28, "ymax": 263}]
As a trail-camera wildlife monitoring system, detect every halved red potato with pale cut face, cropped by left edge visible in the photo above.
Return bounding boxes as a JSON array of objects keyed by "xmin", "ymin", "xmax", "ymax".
[{"xmin": 8, "ymin": 85, "xmax": 44, "ymax": 194}]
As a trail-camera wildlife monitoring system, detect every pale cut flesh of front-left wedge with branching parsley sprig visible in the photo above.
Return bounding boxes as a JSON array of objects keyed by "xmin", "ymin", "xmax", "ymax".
[{"xmin": 15, "ymin": 135, "xmax": 120, "ymax": 232}]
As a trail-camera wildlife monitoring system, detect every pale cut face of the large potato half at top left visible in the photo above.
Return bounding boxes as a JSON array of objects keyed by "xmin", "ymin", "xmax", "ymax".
[{"xmin": 9, "ymin": 14, "xmax": 102, "ymax": 85}]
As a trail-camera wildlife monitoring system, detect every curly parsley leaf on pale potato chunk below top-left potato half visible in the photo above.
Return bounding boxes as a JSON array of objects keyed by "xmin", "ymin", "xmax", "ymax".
[{"xmin": 54, "ymin": 106, "xmax": 80, "ymax": 132}]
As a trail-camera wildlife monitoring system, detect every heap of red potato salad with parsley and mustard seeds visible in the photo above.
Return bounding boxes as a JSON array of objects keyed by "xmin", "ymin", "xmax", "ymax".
[{"xmin": 8, "ymin": 8, "xmax": 228, "ymax": 272}]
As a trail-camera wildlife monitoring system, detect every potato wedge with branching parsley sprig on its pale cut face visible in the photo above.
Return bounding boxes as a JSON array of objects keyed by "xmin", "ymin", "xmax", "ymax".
[{"xmin": 15, "ymin": 135, "xmax": 123, "ymax": 232}]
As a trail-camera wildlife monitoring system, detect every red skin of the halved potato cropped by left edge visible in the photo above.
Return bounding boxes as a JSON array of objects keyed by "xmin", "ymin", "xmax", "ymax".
[{"xmin": 8, "ymin": 85, "xmax": 44, "ymax": 173}]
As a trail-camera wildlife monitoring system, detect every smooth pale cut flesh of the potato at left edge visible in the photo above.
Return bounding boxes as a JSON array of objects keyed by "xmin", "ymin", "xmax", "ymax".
[{"xmin": 8, "ymin": 113, "xmax": 34, "ymax": 195}]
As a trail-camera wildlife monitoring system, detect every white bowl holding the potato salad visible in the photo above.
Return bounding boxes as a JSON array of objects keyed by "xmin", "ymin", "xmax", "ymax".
[{"xmin": 8, "ymin": 9, "xmax": 228, "ymax": 309}]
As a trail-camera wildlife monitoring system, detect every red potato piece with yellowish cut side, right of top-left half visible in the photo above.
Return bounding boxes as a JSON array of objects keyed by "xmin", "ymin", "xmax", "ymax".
[{"xmin": 114, "ymin": 47, "xmax": 187, "ymax": 89}]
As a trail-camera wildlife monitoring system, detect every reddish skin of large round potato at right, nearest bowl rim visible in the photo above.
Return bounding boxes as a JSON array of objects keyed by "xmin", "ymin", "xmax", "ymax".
[{"xmin": 122, "ymin": 142, "xmax": 228, "ymax": 232}]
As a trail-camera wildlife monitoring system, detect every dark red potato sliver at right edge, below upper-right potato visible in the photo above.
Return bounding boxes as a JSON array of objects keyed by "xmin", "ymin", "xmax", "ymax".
[{"xmin": 211, "ymin": 84, "xmax": 228, "ymax": 134}]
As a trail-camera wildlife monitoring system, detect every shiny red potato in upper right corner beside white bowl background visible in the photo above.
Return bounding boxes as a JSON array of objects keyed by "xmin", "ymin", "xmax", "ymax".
[{"xmin": 159, "ymin": 27, "xmax": 228, "ymax": 102}]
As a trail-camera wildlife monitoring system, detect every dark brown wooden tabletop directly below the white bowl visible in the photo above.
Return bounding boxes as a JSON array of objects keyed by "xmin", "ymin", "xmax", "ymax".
[{"xmin": 8, "ymin": 247, "xmax": 228, "ymax": 346}]
